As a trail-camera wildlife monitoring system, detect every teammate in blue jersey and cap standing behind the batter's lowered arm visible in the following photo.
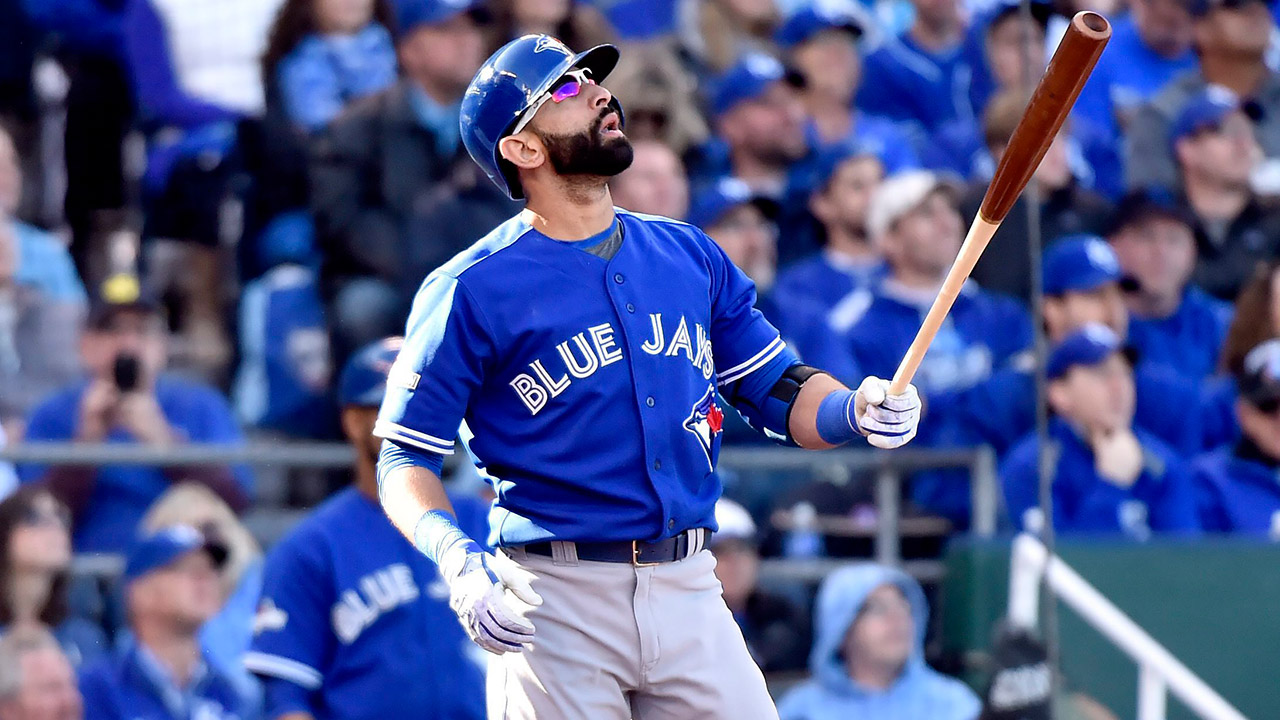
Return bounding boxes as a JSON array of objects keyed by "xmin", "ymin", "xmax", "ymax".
[{"xmin": 244, "ymin": 338, "xmax": 485, "ymax": 720}]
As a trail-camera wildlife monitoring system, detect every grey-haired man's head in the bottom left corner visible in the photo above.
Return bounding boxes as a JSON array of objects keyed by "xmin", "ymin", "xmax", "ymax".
[{"xmin": 0, "ymin": 628, "xmax": 84, "ymax": 720}]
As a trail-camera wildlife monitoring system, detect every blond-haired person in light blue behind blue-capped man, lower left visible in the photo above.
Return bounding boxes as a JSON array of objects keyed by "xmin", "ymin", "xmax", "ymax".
[{"xmin": 141, "ymin": 483, "xmax": 262, "ymax": 708}]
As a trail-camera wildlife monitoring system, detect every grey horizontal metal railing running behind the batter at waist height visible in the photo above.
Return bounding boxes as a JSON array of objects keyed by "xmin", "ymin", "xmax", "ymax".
[{"xmin": 0, "ymin": 441, "xmax": 1000, "ymax": 565}]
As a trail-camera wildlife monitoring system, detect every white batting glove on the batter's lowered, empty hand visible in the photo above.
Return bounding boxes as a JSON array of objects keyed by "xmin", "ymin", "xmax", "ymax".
[{"xmin": 449, "ymin": 552, "xmax": 543, "ymax": 655}]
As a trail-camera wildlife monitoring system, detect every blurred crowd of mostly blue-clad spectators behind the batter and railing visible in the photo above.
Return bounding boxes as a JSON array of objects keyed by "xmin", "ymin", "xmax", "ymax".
[{"xmin": 0, "ymin": 0, "xmax": 1280, "ymax": 720}]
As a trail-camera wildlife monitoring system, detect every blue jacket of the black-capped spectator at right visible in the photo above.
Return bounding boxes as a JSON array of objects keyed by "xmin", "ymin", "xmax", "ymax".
[{"xmin": 1129, "ymin": 287, "xmax": 1231, "ymax": 380}]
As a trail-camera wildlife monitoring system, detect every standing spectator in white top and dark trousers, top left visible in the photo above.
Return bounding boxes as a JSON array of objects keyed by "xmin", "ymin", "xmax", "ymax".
[{"xmin": 122, "ymin": 0, "xmax": 288, "ymax": 378}]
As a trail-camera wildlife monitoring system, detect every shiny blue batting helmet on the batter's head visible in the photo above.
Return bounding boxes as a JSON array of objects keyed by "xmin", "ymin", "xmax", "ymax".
[{"xmin": 458, "ymin": 35, "xmax": 622, "ymax": 200}]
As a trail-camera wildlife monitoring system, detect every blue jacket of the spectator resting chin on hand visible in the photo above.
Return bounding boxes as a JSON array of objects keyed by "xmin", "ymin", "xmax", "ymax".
[{"xmin": 1000, "ymin": 418, "xmax": 1199, "ymax": 539}]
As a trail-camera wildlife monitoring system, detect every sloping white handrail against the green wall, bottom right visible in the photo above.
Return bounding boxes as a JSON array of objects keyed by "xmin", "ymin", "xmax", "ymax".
[{"xmin": 1009, "ymin": 534, "xmax": 1245, "ymax": 720}]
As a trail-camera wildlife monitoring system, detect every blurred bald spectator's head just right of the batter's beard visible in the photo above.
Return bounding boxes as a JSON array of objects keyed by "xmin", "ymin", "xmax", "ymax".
[{"xmin": 609, "ymin": 139, "xmax": 689, "ymax": 220}]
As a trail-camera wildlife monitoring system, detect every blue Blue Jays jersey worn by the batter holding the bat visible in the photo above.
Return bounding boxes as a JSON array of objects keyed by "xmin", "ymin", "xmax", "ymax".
[{"xmin": 374, "ymin": 210, "xmax": 796, "ymax": 546}]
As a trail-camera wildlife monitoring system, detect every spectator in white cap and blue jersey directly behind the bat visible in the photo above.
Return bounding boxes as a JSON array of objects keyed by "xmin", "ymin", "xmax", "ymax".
[{"xmin": 828, "ymin": 170, "xmax": 1032, "ymax": 527}]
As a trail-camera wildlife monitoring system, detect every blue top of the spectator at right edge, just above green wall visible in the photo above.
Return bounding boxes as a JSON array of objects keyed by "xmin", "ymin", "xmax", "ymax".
[{"xmin": 1192, "ymin": 447, "xmax": 1280, "ymax": 536}]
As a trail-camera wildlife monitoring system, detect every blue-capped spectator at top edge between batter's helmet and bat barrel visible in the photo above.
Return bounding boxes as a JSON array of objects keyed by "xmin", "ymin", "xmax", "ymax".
[{"xmin": 776, "ymin": 0, "xmax": 920, "ymax": 174}]
